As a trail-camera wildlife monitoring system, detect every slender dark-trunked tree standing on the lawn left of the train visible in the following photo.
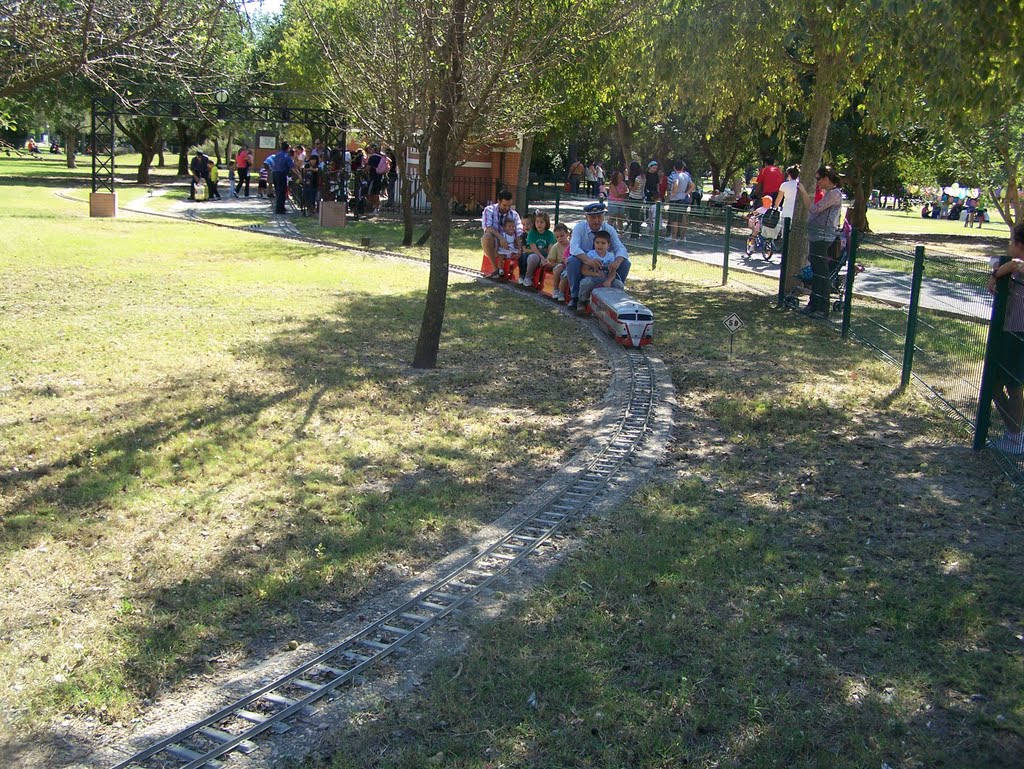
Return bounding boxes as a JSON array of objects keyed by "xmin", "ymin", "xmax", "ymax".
[{"xmin": 296, "ymin": 0, "xmax": 626, "ymax": 369}]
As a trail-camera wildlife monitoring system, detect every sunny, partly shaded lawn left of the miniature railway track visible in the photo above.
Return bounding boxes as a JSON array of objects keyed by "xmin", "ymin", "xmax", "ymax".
[{"xmin": 0, "ymin": 184, "xmax": 607, "ymax": 741}]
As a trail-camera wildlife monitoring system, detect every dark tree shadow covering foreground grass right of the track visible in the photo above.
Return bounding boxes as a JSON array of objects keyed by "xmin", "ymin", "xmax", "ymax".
[{"xmin": 332, "ymin": 423, "xmax": 1024, "ymax": 768}]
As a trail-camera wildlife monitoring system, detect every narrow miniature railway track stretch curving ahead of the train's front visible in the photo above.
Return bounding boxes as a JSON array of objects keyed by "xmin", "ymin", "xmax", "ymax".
[{"xmin": 112, "ymin": 351, "xmax": 656, "ymax": 769}]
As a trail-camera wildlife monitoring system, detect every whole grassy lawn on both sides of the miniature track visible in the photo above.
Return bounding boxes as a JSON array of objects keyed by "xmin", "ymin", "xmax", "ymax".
[{"xmin": 0, "ymin": 176, "xmax": 1024, "ymax": 769}]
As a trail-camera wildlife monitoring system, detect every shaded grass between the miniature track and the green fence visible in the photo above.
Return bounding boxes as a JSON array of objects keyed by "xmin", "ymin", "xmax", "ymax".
[{"xmin": 319, "ymin": 281, "xmax": 1024, "ymax": 769}]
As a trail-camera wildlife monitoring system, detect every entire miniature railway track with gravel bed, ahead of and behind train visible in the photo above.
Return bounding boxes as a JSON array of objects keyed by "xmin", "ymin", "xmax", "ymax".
[{"xmin": 56, "ymin": 188, "xmax": 671, "ymax": 769}]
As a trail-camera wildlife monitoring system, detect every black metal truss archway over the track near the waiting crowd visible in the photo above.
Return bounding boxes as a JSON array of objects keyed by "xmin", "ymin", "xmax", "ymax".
[{"xmin": 91, "ymin": 91, "xmax": 347, "ymax": 193}]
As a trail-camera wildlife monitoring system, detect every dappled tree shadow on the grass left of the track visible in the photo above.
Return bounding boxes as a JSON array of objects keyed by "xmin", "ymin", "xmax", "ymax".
[{"xmin": 2, "ymin": 285, "xmax": 593, "ymax": 741}]
